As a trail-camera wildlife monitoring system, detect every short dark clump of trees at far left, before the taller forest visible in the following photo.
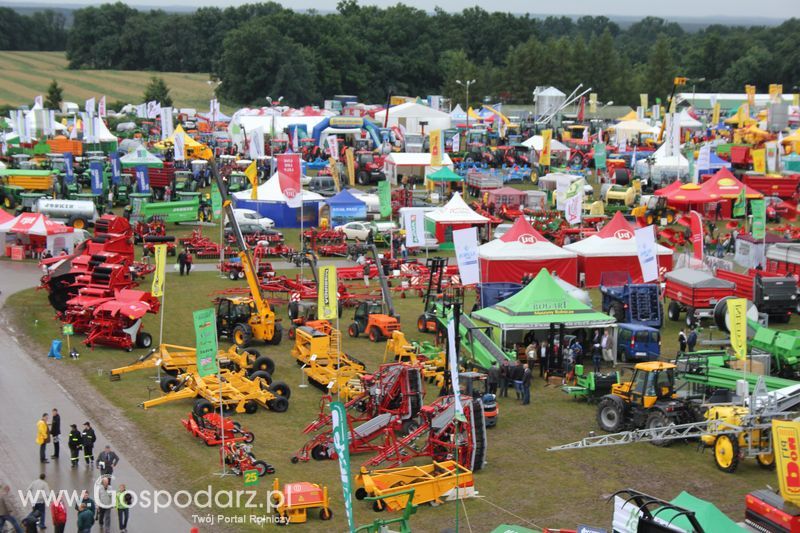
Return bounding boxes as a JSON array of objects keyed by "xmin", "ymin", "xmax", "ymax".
[{"xmin": 0, "ymin": 7, "xmax": 67, "ymax": 51}]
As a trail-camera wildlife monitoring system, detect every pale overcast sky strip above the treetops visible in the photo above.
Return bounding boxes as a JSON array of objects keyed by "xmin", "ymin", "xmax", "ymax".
[{"xmin": 14, "ymin": 0, "xmax": 800, "ymax": 19}]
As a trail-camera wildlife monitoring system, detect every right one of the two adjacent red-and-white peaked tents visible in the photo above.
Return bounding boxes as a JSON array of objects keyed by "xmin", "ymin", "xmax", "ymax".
[{"xmin": 564, "ymin": 211, "xmax": 672, "ymax": 287}]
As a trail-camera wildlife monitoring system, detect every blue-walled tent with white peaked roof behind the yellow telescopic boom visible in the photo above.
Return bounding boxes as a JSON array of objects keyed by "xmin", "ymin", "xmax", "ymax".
[{"xmin": 233, "ymin": 172, "xmax": 325, "ymax": 228}]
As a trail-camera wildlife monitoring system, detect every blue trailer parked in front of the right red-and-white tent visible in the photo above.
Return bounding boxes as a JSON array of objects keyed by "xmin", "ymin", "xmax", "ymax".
[{"xmin": 600, "ymin": 271, "xmax": 663, "ymax": 328}]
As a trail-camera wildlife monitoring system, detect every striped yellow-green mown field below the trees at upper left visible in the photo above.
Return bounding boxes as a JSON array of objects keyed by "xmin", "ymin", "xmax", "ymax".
[{"xmin": 0, "ymin": 52, "xmax": 216, "ymax": 110}]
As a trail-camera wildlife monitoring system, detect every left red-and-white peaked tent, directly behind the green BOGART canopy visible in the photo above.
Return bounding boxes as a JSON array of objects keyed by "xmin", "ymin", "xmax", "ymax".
[{"xmin": 478, "ymin": 217, "xmax": 578, "ymax": 285}]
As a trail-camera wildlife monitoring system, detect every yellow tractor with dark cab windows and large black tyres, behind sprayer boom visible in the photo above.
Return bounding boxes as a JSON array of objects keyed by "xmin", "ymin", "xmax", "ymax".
[{"xmin": 597, "ymin": 361, "xmax": 702, "ymax": 446}]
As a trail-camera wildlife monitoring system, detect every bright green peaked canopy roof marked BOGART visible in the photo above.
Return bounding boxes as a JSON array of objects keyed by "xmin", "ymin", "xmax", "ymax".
[{"xmin": 472, "ymin": 268, "xmax": 616, "ymax": 331}]
